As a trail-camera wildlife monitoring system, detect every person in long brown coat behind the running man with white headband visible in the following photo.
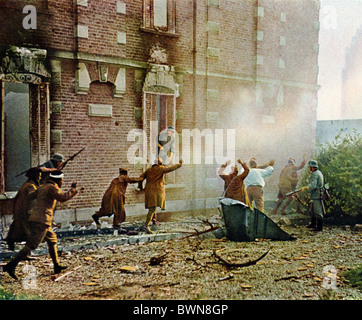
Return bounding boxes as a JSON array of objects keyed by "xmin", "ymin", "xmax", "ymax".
[{"xmin": 5, "ymin": 168, "xmax": 41, "ymax": 250}]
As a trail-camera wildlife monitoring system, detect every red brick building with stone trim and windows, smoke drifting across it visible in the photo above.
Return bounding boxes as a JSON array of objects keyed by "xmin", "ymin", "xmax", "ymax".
[{"xmin": 0, "ymin": 0, "xmax": 319, "ymax": 220}]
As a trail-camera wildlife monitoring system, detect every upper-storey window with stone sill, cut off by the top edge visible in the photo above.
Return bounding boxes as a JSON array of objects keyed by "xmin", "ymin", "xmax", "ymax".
[{"xmin": 143, "ymin": 0, "xmax": 176, "ymax": 34}]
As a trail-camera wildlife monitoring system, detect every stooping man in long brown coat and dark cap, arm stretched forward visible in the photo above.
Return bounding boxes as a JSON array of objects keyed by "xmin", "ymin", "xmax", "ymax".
[{"xmin": 92, "ymin": 168, "xmax": 143, "ymax": 228}]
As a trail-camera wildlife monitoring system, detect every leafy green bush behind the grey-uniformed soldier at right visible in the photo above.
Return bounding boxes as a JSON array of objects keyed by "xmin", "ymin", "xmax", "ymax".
[{"xmin": 300, "ymin": 132, "xmax": 362, "ymax": 217}]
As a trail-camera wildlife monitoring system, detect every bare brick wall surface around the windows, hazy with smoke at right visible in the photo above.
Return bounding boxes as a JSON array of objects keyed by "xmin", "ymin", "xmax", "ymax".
[{"xmin": 2, "ymin": 0, "xmax": 318, "ymax": 215}]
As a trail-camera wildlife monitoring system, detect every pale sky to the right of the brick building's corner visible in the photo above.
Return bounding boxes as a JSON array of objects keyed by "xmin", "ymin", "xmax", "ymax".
[{"xmin": 317, "ymin": 0, "xmax": 362, "ymax": 120}]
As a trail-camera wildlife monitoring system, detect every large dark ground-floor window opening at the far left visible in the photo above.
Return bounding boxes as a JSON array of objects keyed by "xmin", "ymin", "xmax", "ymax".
[{"xmin": 0, "ymin": 80, "xmax": 50, "ymax": 193}]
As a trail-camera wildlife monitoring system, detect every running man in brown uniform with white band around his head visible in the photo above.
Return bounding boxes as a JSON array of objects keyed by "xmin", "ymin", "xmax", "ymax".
[{"xmin": 3, "ymin": 171, "xmax": 77, "ymax": 280}]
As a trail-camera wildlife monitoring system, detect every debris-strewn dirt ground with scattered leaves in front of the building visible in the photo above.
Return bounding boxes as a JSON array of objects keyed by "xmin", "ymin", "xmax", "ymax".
[{"xmin": 0, "ymin": 211, "xmax": 362, "ymax": 300}]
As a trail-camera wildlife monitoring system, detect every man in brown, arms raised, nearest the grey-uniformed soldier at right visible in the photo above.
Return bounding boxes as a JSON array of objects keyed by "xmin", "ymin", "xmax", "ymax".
[{"xmin": 271, "ymin": 158, "xmax": 305, "ymax": 214}]
